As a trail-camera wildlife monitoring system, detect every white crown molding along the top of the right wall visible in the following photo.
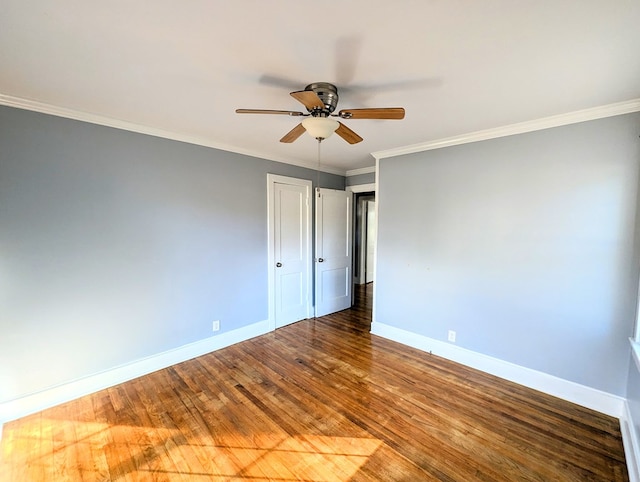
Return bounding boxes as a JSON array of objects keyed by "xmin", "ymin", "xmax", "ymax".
[{"xmin": 371, "ymin": 99, "xmax": 640, "ymax": 159}]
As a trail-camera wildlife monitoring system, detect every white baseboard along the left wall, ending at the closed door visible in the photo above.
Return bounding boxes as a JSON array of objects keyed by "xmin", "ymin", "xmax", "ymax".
[{"xmin": 0, "ymin": 321, "xmax": 269, "ymax": 424}]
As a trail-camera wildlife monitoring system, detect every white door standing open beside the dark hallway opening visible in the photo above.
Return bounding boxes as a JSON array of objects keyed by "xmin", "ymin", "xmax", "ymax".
[{"xmin": 315, "ymin": 189, "xmax": 352, "ymax": 316}]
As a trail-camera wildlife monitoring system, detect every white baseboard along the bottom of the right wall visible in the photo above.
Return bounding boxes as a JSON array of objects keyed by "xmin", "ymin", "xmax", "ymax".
[{"xmin": 371, "ymin": 320, "xmax": 625, "ymax": 418}]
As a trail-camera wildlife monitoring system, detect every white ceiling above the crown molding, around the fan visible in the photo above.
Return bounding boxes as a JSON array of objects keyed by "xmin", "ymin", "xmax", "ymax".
[{"xmin": 0, "ymin": 0, "xmax": 640, "ymax": 171}]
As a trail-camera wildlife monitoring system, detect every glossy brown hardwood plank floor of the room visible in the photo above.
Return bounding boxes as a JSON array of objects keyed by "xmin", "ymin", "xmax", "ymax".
[{"xmin": 0, "ymin": 285, "xmax": 628, "ymax": 482}]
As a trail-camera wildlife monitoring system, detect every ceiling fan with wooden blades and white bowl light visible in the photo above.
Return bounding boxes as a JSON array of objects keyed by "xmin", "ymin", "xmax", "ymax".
[{"xmin": 236, "ymin": 82, "xmax": 404, "ymax": 144}]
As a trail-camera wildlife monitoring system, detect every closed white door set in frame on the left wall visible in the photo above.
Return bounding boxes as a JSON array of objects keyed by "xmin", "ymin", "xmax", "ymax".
[{"xmin": 272, "ymin": 182, "xmax": 311, "ymax": 328}]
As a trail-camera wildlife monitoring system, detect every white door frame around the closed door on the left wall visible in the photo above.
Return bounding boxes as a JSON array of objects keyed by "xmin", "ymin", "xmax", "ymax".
[{"xmin": 267, "ymin": 174, "xmax": 313, "ymax": 331}]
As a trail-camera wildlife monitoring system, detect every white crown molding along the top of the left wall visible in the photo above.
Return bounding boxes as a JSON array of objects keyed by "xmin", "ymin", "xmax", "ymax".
[{"xmin": 0, "ymin": 93, "xmax": 345, "ymax": 176}]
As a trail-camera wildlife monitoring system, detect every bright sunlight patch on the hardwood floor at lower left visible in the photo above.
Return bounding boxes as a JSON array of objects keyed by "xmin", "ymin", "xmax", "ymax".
[{"xmin": 0, "ymin": 417, "xmax": 382, "ymax": 482}]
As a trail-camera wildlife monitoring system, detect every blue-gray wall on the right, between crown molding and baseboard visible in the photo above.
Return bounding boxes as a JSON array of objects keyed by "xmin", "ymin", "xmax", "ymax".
[{"xmin": 376, "ymin": 113, "xmax": 640, "ymax": 396}]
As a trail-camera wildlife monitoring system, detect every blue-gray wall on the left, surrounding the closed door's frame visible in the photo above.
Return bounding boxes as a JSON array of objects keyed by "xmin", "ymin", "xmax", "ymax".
[{"xmin": 0, "ymin": 107, "xmax": 344, "ymax": 402}]
